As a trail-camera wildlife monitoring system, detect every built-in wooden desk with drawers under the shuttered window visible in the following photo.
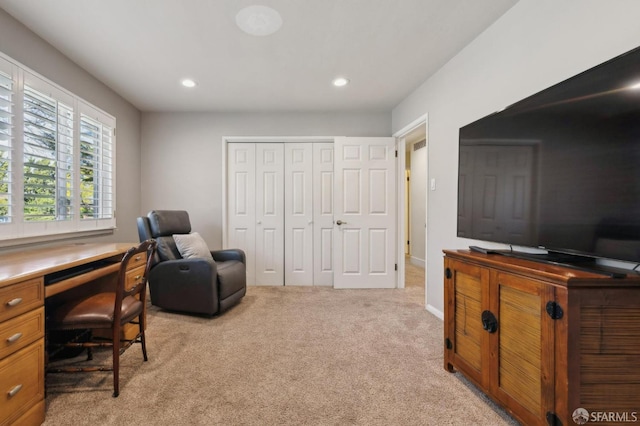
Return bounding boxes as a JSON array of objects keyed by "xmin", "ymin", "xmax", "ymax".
[{"xmin": 0, "ymin": 243, "xmax": 138, "ymax": 425}]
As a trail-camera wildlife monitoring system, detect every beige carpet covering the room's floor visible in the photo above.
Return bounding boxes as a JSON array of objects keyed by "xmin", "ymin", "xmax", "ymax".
[{"xmin": 44, "ymin": 265, "xmax": 516, "ymax": 426}]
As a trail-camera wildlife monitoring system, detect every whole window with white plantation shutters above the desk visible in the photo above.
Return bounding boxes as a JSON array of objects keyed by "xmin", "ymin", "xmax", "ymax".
[{"xmin": 0, "ymin": 52, "xmax": 115, "ymax": 245}]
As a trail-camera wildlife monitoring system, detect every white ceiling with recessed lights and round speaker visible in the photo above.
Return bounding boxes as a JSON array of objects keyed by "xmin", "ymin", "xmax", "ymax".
[{"xmin": 0, "ymin": 0, "xmax": 517, "ymax": 111}]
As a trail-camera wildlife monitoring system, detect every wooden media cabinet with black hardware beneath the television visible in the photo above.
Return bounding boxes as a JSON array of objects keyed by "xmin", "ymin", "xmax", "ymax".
[{"xmin": 444, "ymin": 250, "xmax": 640, "ymax": 425}]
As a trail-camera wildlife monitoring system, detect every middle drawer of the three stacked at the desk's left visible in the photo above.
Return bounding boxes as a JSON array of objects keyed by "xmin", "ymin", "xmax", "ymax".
[{"xmin": 0, "ymin": 307, "xmax": 44, "ymax": 359}]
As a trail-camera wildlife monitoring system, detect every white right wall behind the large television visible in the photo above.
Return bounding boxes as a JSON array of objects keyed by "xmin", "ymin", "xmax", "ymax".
[{"xmin": 392, "ymin": 0, "xmax": 640, "ymax": 314}]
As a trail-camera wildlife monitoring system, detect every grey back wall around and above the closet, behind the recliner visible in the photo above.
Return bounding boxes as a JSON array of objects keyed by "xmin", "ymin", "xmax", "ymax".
[{"xmin": 141, "ymin": 112, "xmax": 391, "ymax": 250}]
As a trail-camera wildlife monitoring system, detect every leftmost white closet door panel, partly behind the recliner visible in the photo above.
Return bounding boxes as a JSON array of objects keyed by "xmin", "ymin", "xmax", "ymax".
[{"xmin": 227, "ymin": 143, "xmax": 256, "ymax": 284}]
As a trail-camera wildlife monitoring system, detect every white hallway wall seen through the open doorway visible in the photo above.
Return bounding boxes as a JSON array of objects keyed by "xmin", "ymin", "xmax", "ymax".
[{"xmin": 409, "ymin": 146, "xmax": 427, "ymax": 267}]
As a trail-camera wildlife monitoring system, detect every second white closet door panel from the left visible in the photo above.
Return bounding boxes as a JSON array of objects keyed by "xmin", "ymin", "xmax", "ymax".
[{"xmin": 255, "ymin": 143, "xmax": 284, "ymax": 285}]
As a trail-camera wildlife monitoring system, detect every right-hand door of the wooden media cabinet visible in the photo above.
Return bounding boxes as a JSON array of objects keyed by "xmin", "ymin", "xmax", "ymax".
[{"xmin": 489, "ymin": 271, "xmax": 555, "ymax": 424}]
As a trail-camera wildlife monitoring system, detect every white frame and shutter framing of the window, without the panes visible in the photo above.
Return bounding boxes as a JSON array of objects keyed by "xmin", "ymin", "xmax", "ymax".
[{"xmin": 0, "ymin": 52, "xmax": 117, "ymax": 247}]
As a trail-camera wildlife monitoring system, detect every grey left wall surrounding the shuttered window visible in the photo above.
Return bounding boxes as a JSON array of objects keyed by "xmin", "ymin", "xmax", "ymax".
[{"xmin": 0, "ymin": 9, "xmax": 140, "ymax": 248}]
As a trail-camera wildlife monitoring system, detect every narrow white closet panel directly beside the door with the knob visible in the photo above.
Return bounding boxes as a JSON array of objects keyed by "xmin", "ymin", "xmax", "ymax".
[{"xmin": 313, "ymin": 143, "xmax": 334, "ymax": 286}]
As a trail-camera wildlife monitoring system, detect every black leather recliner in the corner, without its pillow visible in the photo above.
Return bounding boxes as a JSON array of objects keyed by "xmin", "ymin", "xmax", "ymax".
[{"xmin": 138, "ymin": 210, "xmax": 247, "ymax": 315}]
